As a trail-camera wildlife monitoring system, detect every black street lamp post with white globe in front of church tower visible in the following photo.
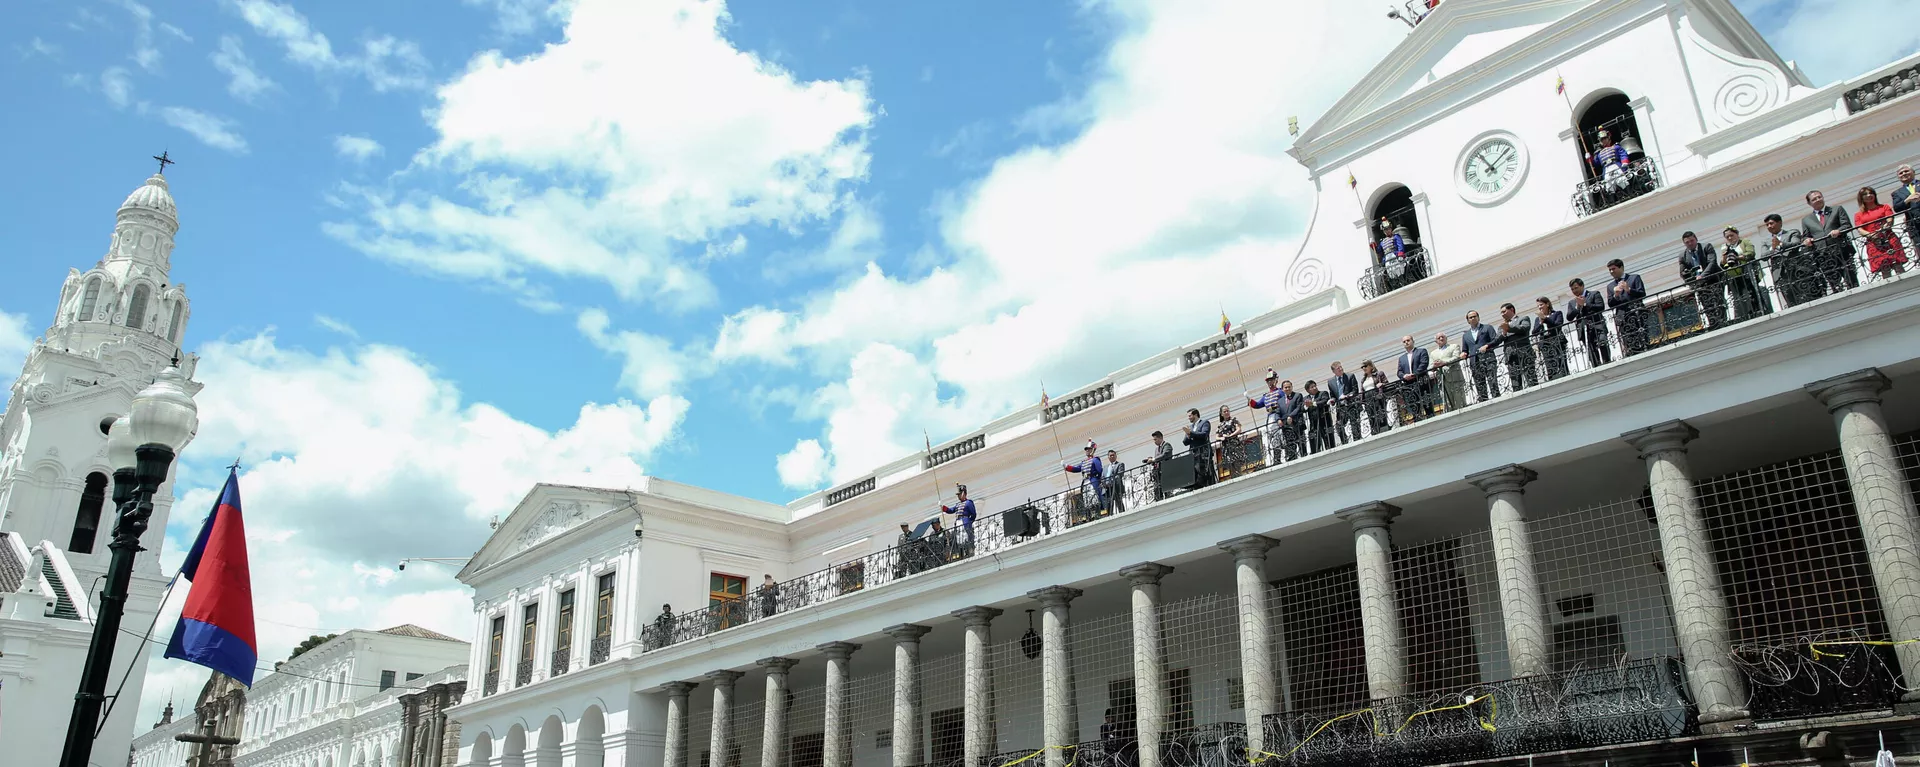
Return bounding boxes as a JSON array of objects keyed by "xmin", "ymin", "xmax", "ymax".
[{"xmin": 60, "ymin": 359, "xmax": 200, "ymax": 767}]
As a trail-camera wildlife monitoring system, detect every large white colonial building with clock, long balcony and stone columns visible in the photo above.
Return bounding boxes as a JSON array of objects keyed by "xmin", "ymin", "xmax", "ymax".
[{"xmin": 453, "ymin": 0, "xmax": 1920, "ymax": 767}]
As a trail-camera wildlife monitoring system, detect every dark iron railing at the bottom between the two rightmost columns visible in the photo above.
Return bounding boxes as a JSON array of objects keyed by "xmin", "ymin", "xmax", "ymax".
[{"xmin": 1732, "ymin": 632, "xmax": 1901, "ymax": 721}]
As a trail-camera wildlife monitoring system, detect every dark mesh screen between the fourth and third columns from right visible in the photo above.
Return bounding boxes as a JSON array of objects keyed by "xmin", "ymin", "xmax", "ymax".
[{"xmin": 1394, "ymin": 531, "xmax": 1505, "ymax": 696}]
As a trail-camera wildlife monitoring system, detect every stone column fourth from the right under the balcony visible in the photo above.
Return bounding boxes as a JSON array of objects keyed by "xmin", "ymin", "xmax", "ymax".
[{"xmin": 1334, "ymin": 502, "xmax": 1407, "ymax": 700}]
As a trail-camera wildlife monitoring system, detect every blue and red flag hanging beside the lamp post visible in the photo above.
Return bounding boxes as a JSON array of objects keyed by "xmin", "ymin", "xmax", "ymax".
[{"xmin": 167, "ymin": 469, "xmax": 259, "ymax": 686}]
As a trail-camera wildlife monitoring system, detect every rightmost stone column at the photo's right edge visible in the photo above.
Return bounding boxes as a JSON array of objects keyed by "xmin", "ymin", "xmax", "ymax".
[{"xmin": 1807, "ymin": 367, "xmax": 1920, "ymax": 702}]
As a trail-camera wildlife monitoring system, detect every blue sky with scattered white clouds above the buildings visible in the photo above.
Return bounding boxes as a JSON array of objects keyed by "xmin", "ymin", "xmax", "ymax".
[{"xmin": 0, "ymin": 0, "xmax": 1920, "ymax": 734}]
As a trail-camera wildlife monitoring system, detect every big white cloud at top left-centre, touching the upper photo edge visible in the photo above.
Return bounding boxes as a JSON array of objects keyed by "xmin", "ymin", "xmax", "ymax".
[{"xmin": 328, "ymin": 0, "xmax": 874, "ymax": 308}]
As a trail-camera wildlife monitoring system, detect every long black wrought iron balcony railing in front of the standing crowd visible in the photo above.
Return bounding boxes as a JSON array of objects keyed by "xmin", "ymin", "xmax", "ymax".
[{"xmin": 633, "ymin": 223, "xmax": 1912, "ymax": 663}]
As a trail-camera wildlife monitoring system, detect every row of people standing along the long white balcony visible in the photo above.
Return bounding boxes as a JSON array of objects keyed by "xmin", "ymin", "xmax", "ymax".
[{"xmin": 645, "ymin": 165, "xmax": 1920, "ymax": 650}]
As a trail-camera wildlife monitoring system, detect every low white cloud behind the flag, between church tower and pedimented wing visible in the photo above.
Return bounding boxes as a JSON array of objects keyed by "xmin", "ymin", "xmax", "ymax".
[{"xmin": 142, "ymin": 334, "xmax": 687, "ymax": 719}]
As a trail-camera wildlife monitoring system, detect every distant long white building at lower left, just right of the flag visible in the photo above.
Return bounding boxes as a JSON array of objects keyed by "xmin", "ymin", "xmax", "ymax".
[{"xmin": 132, "ymin": 625, "xmax": 467, "ymax": 767}]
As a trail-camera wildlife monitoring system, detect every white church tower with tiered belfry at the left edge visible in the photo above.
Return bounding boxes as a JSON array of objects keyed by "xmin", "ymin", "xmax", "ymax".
[{"xmin": 0, "ymin": 165, "xmax": 202, "ymax": 765}]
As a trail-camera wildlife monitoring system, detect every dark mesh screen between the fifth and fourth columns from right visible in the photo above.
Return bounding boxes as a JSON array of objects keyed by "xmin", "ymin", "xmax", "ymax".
[{"xmin": 1271, "ymin": 565, "xmax": 1367, "ymax": 711}]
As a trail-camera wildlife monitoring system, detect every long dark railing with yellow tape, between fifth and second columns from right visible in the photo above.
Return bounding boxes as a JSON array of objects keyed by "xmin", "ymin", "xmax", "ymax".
[{"xmin": 1265, "ymin": 657, "xmax": 1697, "ymax": 767}]
